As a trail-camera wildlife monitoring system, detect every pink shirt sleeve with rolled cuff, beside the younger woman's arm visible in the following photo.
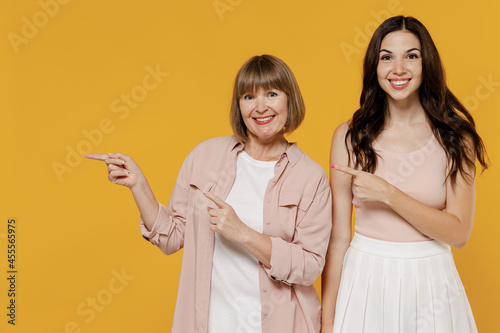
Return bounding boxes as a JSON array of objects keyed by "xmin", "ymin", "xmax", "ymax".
[{"xmin": 264, "ymin": 182, "xmax": 332, "ymax": 285}]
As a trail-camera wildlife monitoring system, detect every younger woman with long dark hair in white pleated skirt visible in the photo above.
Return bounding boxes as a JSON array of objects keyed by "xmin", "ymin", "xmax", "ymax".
[{"xmin": 322, "ymin": 16, "xmax": 487, "ymax": 333}]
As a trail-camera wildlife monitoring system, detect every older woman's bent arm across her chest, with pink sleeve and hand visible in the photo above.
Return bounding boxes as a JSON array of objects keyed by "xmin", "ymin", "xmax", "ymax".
[{"xmin": 204, "ymin": 184, "xmax": 331, "ymax": 285}]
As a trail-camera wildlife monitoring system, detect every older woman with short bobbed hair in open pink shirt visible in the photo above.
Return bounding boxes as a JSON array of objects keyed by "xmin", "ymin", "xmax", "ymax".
[{"xmin": 87, "ymin": 55, "xmax": 331, "ymax": 333}]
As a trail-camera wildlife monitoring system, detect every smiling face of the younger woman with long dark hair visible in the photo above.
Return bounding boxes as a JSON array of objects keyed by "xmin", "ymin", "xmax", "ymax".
[{"xmin": 377, "ymin": 30, "xmax": 422, "ymax": 102}]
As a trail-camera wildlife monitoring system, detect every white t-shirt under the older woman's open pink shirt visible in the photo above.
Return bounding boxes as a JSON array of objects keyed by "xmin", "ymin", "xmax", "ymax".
[{"xmin": 208, "ymin": 151, "xmax": 276, "ymax": 333}]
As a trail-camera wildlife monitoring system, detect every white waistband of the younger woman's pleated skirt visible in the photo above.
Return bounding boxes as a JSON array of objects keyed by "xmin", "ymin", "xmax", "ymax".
[{"xmin": 351, "ymin": 232, "xmax": 451, "ymax": 259}]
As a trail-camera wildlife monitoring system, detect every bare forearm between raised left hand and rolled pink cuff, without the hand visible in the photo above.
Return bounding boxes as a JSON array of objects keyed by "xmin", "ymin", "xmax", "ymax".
[{"xmin": 130, "ymin": 176, "xmax": 159, "ymax": 231}]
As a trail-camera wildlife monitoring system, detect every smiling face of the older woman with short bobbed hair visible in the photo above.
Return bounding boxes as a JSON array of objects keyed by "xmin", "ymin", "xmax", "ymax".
[{"xmin": 239, "ymin": 87, "xmax": 288, "ymax": 142}]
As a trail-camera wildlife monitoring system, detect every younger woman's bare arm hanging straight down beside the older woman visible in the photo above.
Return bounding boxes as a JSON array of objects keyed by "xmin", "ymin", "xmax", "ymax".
[{"xmin": 321, "ymin": 123, "xmax": 352, "ymax": 333}]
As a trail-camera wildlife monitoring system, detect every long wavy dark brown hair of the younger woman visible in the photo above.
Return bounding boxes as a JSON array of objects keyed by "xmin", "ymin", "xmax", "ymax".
[{"xmin": 345, "ymin": 16, "xmax": 488, "ymax": 183}]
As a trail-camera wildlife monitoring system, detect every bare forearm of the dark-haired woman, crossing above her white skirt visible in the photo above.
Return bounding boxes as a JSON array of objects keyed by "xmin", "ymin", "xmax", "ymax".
[{"xmin": 384, "ymin": 187, "xmax": 473, "ymax": 248}]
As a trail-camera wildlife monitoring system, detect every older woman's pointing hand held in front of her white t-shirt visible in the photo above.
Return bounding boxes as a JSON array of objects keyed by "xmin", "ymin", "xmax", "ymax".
[{"xmin": 204, "ymin": 192, "xmax": 248, "ymax": 243}]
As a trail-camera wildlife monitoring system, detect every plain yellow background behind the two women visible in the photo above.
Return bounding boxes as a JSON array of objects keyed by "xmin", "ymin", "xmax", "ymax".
[{"xmin": 0, "ymin": 0, "xmax": 500, "ymax": 333}]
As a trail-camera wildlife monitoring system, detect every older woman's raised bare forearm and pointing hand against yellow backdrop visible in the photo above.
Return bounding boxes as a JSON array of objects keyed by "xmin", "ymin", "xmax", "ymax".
[{"xmin": 85, "ymin": 153, "xmax": 159, "ymax": 230}]
